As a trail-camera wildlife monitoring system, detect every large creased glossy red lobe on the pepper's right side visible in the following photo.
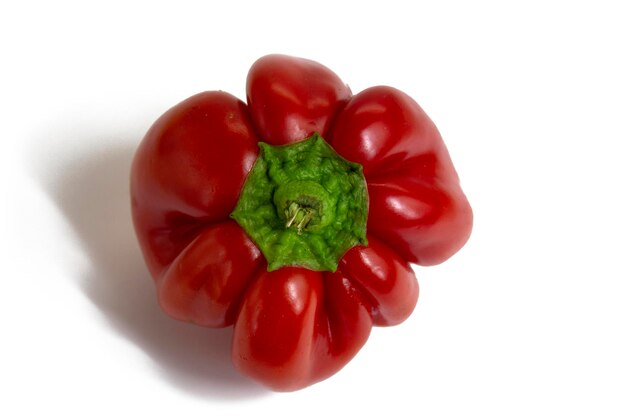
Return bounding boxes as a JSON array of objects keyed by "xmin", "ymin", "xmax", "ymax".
[{"xmin": 330, "ymin": 86, "xmax": 472, "ymax": 265}]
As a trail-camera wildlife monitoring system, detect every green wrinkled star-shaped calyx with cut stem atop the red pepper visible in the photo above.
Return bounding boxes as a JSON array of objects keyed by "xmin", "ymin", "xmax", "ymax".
[{"xmin": 231, "ymin": 133, "xmax": 368, "ymax": 271}]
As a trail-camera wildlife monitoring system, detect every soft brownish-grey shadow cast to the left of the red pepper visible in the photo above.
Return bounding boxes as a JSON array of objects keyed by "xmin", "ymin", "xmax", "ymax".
[{"xmin": 35, "ymin": 138, "xmax": 268, "ymax": 400}]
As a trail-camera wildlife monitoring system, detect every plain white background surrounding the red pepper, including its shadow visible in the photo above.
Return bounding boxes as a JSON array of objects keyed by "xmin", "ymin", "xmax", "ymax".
[{"xmin": 0, "ymin": 0, "xmax": 626, "ymax": 416}]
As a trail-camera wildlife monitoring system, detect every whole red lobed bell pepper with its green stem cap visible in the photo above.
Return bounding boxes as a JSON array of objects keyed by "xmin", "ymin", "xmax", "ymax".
[{"xmin": 131, "ymin": 55, "xmax": 472, "ymax": 391}]
